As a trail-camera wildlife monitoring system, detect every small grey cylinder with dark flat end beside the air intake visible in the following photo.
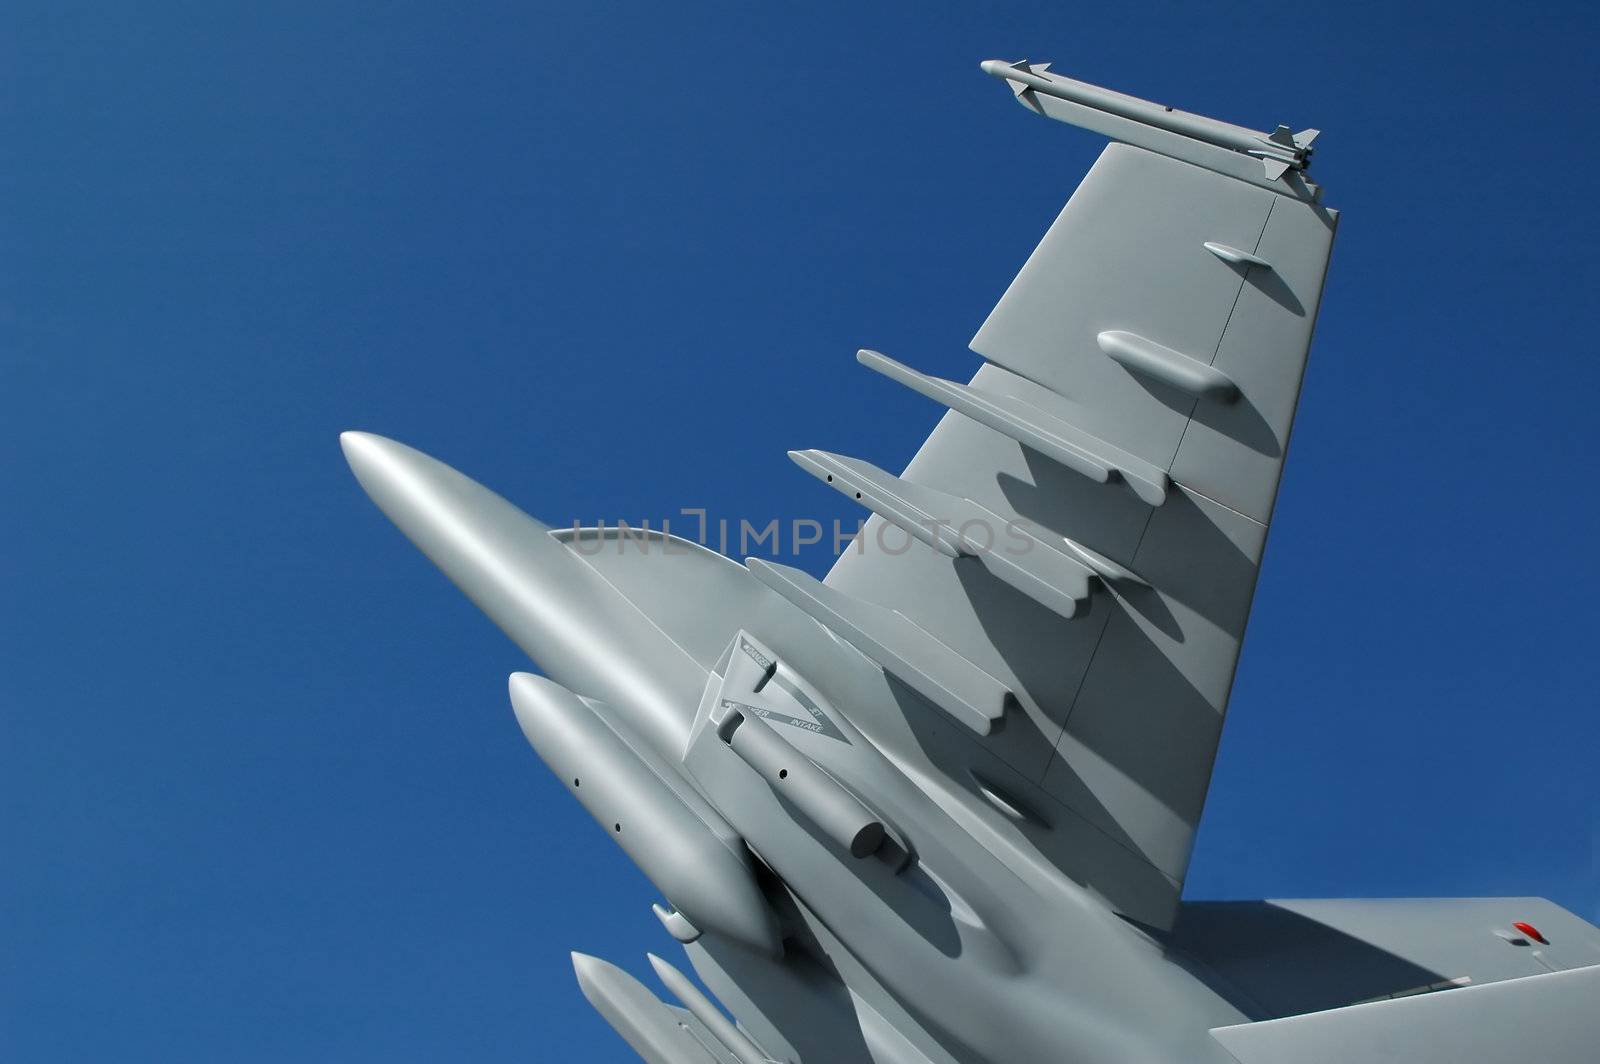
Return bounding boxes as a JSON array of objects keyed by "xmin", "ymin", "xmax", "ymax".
[{"xmin": 717, "ymin": 709, "xmax": 883, "ymax": 858}]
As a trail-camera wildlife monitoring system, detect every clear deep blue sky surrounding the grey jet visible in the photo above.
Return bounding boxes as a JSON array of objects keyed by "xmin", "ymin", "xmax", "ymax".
[{"xmin": 0, "ymin": 2, "xmax": 1600, "ymax": 1064}]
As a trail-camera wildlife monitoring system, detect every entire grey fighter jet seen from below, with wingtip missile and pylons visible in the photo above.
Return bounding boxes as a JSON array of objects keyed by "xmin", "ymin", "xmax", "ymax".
[{"xmin": 342, "ymin": 61, "xmax": 1600, "ymax": 1064}]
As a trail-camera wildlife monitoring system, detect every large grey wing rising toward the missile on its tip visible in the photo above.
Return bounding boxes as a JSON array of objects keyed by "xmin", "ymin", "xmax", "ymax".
[{"xmin": 825, "ymin": 74, "xmax": 1338, "ymax": 925}]
